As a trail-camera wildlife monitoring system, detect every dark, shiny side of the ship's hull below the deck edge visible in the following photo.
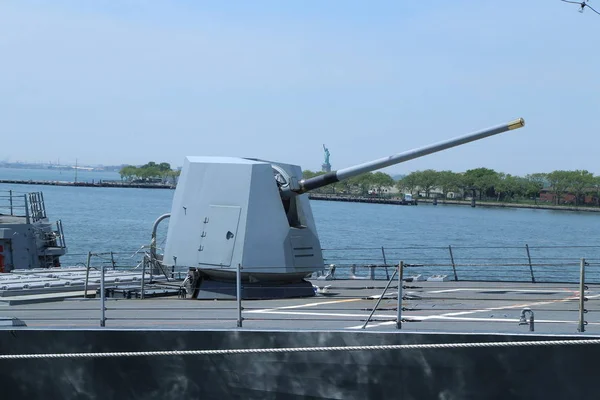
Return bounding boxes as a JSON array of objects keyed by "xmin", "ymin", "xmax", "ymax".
[{"xmin": 0, "ymin": 329, "xmax": 600, "ymax": 400}]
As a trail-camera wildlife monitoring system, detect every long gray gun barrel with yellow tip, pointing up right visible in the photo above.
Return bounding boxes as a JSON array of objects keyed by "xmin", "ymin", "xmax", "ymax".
[{"xmin": 282, "ymin": 118, "xmax": 525, "ymax": 194}]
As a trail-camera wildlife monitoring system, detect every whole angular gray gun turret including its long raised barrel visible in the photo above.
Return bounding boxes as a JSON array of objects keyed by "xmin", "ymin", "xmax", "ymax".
[{"xmin": 157, "ymin": 115, "xmax": 525, "ymax": 299}]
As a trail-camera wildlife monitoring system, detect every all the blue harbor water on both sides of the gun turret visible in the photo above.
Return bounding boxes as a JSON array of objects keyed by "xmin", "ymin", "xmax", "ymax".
[{"xmin": 0, "ymin": 175, "xmax": 600, "ymax": 281}]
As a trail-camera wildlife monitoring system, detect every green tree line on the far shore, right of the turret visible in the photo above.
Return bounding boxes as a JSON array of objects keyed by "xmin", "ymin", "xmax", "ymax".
[{"xmin": 303, "ymin": 168, "xmax": 600, "ymax": 205}]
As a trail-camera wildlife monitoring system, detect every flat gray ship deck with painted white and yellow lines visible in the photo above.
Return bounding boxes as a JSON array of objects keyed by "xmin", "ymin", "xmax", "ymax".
[{"xmin": 0, "ymin": 280, "xmax": 600, "ymax": 335}]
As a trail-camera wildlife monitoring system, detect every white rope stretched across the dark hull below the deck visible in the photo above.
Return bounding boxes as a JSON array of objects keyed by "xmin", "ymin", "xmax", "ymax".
[{"xmin": 0, "ymin": 339, "xmax": 600, "ymax": 360}]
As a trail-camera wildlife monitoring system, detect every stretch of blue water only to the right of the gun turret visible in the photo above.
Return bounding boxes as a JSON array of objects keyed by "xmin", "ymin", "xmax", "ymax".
[{"xmin": 313, "ymin": 201, "xmax": 600, "ymax": 282}]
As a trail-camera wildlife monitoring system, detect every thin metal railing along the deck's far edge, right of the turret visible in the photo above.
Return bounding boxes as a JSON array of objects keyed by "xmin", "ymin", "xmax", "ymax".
[{"xmin": 318, "ymin": 244, "xmax": 600, "ymax": 283}]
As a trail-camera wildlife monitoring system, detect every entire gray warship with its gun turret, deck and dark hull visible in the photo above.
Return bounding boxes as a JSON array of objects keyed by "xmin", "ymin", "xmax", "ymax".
[{"xmin": 0, "ymin": 119, "xmax": 600, "ymax": 399}]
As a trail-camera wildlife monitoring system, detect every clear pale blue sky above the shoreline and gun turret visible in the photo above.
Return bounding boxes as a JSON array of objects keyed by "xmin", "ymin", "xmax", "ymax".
[{"xmin": 0, "ymin": 0, "xmax": 600, "ymax": 175}]
